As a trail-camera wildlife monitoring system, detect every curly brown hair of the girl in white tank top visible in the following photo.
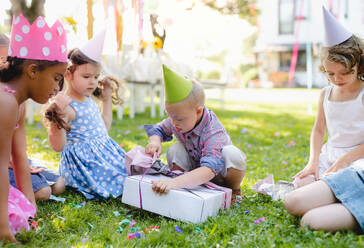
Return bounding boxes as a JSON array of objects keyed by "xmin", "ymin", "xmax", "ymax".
[{"xmin": 319, "ymin": 35, "xmax": 364, "ymax": 81}]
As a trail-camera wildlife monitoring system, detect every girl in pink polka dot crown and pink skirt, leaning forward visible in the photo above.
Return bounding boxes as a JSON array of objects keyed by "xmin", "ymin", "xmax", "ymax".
[{"xmin": 0, "ymin": 15, "xmax": 67, "ymax": 242}]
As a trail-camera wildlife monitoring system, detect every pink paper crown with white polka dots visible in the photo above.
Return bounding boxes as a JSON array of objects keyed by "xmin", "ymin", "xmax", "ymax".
[{"xmin": 8, "ymin": 14, "xmax": 67, "ymax": 62}]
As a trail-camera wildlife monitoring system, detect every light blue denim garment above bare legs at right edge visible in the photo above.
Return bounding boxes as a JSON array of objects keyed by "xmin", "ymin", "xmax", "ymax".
[{"xmin": 321, "ymin": 167, "xmax": 364, "ymax": 231}]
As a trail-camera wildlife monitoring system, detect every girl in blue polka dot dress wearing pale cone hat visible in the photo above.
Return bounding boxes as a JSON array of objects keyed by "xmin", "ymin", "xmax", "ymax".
[{"xmin": 45, "ymin": 29, "xmax": 127, "ymax": 199}]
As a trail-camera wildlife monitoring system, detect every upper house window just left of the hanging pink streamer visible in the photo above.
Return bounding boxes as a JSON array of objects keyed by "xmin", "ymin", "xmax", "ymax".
[{"xmin": 279, "ymin": 0, "xmax": 295, "ymax": 34}]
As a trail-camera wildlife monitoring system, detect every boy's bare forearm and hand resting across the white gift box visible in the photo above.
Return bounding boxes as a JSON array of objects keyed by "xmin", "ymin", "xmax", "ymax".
[{"xmin": 152, "ymin": 166, "xmax": 215, "ymax": 194}]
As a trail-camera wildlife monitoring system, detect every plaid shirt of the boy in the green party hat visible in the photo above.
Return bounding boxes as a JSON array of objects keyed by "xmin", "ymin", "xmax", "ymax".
[{"xmin": 144, "ymin": 107, "xmax": 232, "ymax": 175}]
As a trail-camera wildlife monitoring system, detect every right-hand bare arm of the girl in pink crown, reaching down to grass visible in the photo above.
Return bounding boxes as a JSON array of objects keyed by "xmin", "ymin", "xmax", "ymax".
[{"xmin": 12, "ymin": 104, "xmax": 36, "ymax": 206}]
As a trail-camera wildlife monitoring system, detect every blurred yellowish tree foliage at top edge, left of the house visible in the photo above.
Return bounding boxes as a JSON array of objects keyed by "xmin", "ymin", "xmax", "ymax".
[{"xmin": 202, "ymin": 0, "xmax": 259, "ymax": 25}]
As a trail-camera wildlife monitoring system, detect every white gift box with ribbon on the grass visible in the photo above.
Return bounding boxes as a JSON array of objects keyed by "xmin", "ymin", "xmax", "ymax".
[{"xmin": 122, "ymin": 175, "xmax": 231, "ymax": 223}]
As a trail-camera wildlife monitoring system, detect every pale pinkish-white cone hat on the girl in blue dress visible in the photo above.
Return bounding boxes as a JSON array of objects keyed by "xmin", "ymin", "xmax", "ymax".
[{"xmin": 80, "ymin": 28, "xmax": 106, "ymax": 63}]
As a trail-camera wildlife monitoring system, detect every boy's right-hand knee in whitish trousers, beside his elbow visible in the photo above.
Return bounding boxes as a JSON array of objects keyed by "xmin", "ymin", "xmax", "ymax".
[{"xmin": 221, "ymin": 145, "xmax": 246, "ymax": 171}]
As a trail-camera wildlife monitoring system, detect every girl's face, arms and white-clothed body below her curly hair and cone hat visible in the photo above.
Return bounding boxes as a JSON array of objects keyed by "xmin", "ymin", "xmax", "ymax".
[{"xmin": 293, "ymin": 52, "xmax": 364, "ymax": 188}]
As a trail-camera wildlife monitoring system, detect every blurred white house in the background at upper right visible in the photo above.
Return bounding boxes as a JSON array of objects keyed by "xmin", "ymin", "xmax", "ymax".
[{"xmin": 254, "ymin": 0, "xmax": 364, "ymax": 87}]
